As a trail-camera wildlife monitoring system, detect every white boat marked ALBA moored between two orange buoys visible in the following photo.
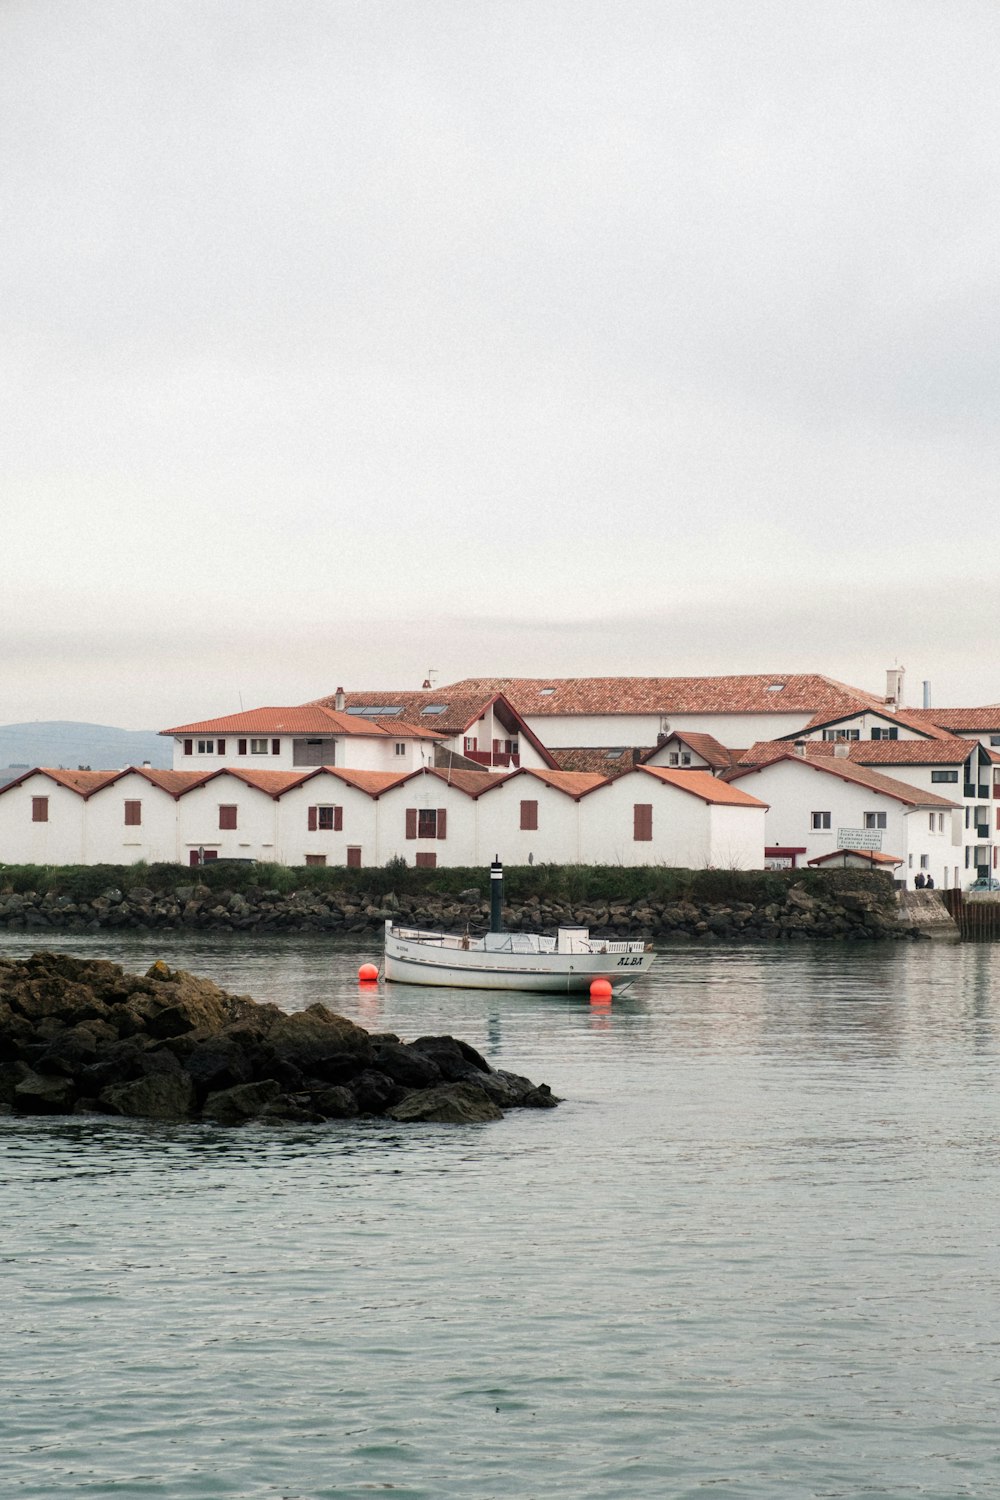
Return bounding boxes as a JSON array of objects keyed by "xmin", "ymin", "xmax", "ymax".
[{"xmin": 384, "ymin": 920, "xmax": 655, "ymax": 995}]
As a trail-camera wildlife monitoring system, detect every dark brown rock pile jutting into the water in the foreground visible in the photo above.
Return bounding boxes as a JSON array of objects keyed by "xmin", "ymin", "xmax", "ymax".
[{"xmin": 0, "ymin": 953, "xmax": 558, "ymax": 1125}]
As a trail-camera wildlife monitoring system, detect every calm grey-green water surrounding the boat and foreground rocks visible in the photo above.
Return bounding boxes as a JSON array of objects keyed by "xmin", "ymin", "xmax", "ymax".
[{"xmin": 0, "ymin": 935, "xmax": 1000, "ymax": 1500}]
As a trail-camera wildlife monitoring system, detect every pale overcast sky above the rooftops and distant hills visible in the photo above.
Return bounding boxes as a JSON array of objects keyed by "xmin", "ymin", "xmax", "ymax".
[{"xmin": 0, "ymin": 0, "xmax": 1000, "ymax": 729}]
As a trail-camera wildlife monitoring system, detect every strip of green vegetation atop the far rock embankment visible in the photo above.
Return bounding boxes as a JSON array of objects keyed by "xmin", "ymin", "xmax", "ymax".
[{"xmin": 0, "ymin": 860, "xmax": 894, "ymax": 906}]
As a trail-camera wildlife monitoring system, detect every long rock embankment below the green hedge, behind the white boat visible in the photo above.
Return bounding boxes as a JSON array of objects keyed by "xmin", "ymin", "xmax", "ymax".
[{"xmin": 0, "ymin": 882, "xmax": 915, "ymax": 942}]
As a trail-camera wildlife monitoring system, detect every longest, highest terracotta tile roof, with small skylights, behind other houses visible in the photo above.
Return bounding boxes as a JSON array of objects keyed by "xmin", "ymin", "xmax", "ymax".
[{"xmin": 435, "ymin": 672, "xmax": 882, "ymax": 717}]
